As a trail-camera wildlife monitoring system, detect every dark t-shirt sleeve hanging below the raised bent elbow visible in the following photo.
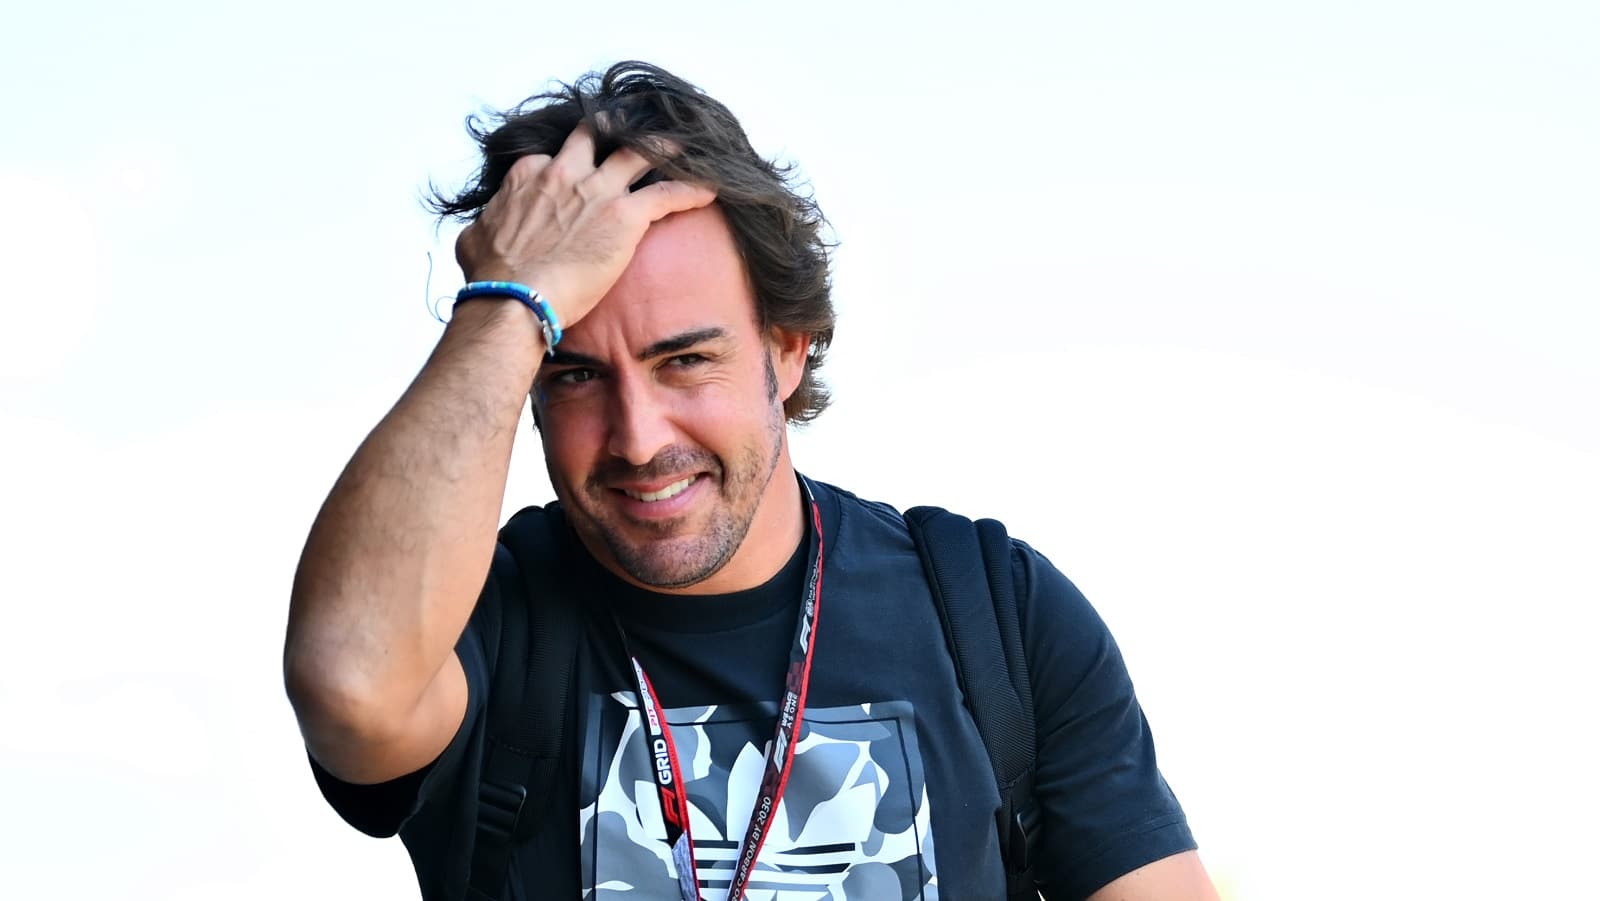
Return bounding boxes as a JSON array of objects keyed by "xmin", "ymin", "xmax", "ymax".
[{"xmin": 307, "ymin": 546, "xmax": 517, "ymax": 839}]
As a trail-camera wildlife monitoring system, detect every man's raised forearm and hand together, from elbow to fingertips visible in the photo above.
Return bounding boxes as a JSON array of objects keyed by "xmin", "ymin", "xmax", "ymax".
[{"xmin": 283, "ymin": 125, "xmax": 715, "ymax": 761}]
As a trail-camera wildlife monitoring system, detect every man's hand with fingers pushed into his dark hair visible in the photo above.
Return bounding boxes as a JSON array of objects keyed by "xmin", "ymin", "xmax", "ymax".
[{"xmin": 456, "ymin": 125, "xmax": 717, "ymax": 328}]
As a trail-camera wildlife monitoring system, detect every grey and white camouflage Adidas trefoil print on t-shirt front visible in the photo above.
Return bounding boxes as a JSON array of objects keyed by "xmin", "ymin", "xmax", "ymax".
[{"xmin": 578, "ymin": 691, "xmax": 939, "ymax": 901}]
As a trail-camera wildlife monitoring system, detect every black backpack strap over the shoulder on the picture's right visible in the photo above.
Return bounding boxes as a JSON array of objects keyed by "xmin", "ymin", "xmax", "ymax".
[{"xmin": 906, "ymin": 507, "xmax": 1038, "ymax": 899}]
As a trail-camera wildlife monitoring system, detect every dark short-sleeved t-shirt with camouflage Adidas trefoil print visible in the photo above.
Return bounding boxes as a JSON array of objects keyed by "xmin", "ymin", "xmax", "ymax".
[{"xmin": 312, "ymin": 482, "xmax": 1195, "ymax": 901}]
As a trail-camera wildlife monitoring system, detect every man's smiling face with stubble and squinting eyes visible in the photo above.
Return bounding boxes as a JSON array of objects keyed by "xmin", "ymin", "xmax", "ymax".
[{"xmin": 534, "ymin": 205, "xmax": 805, "ymax": 591}]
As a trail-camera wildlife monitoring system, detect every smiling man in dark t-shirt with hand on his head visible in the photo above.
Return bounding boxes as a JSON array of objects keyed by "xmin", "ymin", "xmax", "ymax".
[{"xmin": 285, "ymin": 62, "xmax": 1214, "ymax": 901}]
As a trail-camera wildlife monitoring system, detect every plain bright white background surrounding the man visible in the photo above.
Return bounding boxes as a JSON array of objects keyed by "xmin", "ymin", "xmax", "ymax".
[{"xmin": 0, "ymin": 0, "xmax": 1600, "ymax": 901}]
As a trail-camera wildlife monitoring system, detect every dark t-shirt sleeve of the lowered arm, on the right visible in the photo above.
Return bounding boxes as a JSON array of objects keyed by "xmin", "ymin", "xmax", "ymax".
[{"xmin": 1014, "ymin": 543, "xmax": 1195, "ymax": 901}]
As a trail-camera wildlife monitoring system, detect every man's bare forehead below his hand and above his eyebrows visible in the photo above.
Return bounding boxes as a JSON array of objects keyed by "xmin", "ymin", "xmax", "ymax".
[{"xmin": 562, "ymin": 203, "xmax": 755, "ymax": 350}]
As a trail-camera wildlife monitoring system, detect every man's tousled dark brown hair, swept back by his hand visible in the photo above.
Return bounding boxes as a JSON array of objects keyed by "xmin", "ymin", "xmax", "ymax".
[{"xmin": 427, "ymin": 61, "xmax": 834, "ymax": 422}]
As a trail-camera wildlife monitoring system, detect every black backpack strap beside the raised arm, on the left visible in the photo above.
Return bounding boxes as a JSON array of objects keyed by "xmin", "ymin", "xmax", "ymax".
[{"xmin": 467, "ymin": 507, "xmax": 582, "ymax": 901}]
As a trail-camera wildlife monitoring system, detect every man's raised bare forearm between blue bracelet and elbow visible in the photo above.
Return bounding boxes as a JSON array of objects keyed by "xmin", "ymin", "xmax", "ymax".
[{"xmin": 285, "ymin": 299, "xmax": 544, "ymax": 727}]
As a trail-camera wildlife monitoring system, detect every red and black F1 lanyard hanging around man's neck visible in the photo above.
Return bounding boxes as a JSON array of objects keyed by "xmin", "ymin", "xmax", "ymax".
[{"xmin": 618, "ymin": 479, "xmax": 822, "ymax": 901}]
